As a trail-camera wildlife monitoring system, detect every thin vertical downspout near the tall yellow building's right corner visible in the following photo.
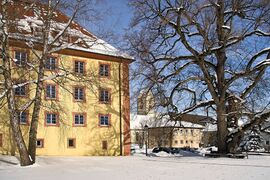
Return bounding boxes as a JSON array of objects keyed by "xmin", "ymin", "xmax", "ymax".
[{"xmin": 118, "ymin": 61, "xmax": 123, "ymax": 156}]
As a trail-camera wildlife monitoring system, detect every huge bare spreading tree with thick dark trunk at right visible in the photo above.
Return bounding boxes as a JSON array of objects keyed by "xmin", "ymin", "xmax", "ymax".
[{"xmin": 128, "ymin": 0, "xmax": 270, "ymax": 153}]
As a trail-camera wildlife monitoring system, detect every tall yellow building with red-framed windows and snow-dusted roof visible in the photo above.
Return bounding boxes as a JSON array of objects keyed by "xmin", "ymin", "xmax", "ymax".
[{"xmin": 0, "ymin": 1, "xmax": 133, "ymax": 156}]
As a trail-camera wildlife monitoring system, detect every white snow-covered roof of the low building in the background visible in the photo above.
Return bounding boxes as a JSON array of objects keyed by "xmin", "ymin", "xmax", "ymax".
[{"xmin": 130, "ymin": 114, "xmax": 204, "ymax": 129}]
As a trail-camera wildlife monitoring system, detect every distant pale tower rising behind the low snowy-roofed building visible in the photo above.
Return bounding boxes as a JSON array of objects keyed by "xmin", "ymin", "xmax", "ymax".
[{"xmin": 137, "ymin": 90, "xmax": 155, "ymax": 115}]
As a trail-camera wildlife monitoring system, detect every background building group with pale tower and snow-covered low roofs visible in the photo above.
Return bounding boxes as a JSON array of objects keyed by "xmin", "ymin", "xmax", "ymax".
[{"xmin": 131, "ymin": 91, "xmax": 211, "ymax": 148}]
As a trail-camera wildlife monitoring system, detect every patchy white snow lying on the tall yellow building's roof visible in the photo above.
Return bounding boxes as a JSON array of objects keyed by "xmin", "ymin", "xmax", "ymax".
[{"xmin": 10, "ymin": 5, "xmax": 134, "ymax": 59}]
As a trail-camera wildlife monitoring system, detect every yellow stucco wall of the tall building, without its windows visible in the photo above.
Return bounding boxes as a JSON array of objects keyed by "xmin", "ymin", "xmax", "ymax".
[{"xmin": 0, "ymin": 46, "xmax": 127, "ymax": 155}]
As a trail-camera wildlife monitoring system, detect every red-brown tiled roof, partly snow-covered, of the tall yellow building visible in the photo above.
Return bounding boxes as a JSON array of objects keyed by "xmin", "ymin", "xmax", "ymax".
[{"xmin": 4, "ymin": 2, "xmax": 134, "ymax": 60}]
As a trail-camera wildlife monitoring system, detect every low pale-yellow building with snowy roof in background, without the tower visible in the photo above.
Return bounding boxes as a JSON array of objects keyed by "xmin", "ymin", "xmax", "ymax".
[{"xmin": 131, "ymin": 114, "xmax": 205, "ymax": 148}]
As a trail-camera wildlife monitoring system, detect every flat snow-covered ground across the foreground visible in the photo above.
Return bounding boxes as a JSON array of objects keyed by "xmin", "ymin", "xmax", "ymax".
[{"xmin": 0, "ymin": 155, "xmax": 270, "ymax": 180}]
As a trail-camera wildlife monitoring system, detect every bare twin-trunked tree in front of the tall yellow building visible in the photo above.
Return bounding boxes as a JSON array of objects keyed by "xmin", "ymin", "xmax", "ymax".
[{"xmin": 1, "ymin": 0, "xmax": 103, "ymax": 166}]
